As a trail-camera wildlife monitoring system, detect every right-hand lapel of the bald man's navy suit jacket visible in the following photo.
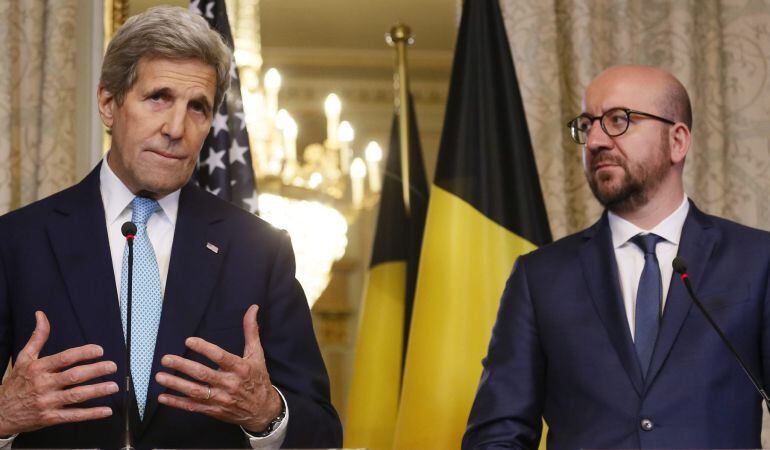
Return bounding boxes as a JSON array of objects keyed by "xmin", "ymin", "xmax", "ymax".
[{"xmin": 647, "ymin": 202, "xmax": 719, "ymax": 388}]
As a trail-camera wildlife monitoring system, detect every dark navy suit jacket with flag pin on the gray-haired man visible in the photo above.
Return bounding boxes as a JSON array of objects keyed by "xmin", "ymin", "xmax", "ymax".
[{"xmin": 0, "ymin": 166, "xmax": 342, "ymax": 448}]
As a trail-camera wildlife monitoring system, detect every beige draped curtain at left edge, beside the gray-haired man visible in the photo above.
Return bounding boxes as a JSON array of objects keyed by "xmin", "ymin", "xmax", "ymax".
[{"xmin": 0, "ymin": 0, "xmax": 78, "ymax": 214}]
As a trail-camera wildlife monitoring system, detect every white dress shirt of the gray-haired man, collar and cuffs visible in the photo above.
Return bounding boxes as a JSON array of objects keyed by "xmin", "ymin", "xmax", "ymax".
[{"xmin": 0, "ymin": 158, "xmax": 289, "ymax": 450}]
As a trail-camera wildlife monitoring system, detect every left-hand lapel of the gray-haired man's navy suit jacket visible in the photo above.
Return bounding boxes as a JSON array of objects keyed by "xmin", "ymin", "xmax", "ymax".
[{"xmin": 48, "ymin": 165, "xmax": 126, "ymax": 414}]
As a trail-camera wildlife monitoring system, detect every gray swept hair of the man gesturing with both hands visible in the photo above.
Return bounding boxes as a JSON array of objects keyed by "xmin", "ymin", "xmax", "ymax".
[{"xmin": 99, "ymin": 6, "xmax": 232, "ymax": 111}]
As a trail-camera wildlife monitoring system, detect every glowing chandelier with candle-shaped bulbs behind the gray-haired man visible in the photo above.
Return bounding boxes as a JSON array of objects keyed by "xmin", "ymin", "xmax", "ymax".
[{"xmin": 227, "ymin": 0, "xmax": 382, "ymax": 307}]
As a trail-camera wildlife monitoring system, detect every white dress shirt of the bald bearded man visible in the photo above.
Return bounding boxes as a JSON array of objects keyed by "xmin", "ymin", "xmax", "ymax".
[{"xmin": 607, "ymin": 196, "xmax": 690, "ymax": 339}]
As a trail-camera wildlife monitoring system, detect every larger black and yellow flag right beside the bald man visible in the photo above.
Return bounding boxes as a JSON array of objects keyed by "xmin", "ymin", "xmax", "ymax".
[{"xmin": 393, "ymin": 0, "xmax": 558, "ymax": 449}]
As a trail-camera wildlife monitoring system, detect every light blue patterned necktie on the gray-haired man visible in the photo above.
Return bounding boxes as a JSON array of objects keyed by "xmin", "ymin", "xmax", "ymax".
[{"xmin": 120, "ymin": 197, "xmax": 162, "ymax": 419}]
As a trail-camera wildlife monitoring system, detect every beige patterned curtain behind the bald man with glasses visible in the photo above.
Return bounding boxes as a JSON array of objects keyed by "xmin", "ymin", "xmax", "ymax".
[{"xmin": 500, "ymin": 0, "xmax": 770, "ymax": 238}]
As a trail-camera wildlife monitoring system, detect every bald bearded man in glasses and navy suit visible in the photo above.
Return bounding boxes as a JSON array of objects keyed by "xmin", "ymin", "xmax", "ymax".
[{"xmin": 463, "ymin": 66, "xmax": 770, "ymax": 450}]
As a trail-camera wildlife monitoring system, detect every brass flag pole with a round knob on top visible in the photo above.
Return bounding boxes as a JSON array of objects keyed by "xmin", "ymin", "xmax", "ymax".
[{"xmin": 386, "ymin": 23, "xmax": 414, "ymax": 216}]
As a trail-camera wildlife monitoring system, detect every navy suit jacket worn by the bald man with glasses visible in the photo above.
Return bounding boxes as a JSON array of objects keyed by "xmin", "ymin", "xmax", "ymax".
[{"xmin": 463, "ymin": 204, "xmax": 770, "ymax": 450}]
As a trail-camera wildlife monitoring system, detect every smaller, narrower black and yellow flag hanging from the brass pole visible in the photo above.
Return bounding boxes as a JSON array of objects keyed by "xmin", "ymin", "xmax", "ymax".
[{"xmin": 345, "ymin": 97, "xmax": 428, "ymax": 450}]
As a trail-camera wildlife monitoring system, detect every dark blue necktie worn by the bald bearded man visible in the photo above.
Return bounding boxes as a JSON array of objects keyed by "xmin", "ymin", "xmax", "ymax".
[{"xmin": 631, "ymin": 233, "xmax": 663, "ymax": 377}]
